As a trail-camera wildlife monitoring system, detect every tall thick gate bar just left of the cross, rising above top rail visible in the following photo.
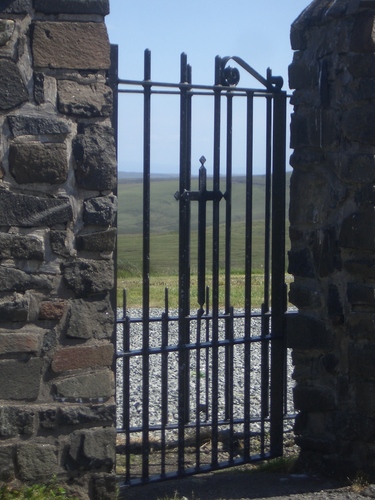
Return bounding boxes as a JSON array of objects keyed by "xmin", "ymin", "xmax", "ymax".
[{"xmin": 178, "ymin": 54, "xmax": 191, "ymax": 474}]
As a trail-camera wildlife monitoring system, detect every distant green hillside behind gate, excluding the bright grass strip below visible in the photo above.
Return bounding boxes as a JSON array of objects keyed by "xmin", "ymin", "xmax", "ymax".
[{"xmin": 118, "ymin": 173, "xmax": 290, "ymax": 276}]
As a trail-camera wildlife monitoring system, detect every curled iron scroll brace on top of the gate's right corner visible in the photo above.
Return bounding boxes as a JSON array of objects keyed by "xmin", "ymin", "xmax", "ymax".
[{"xmin": 216, "ymin": 56, "xmax": 284, "ymax": 92}]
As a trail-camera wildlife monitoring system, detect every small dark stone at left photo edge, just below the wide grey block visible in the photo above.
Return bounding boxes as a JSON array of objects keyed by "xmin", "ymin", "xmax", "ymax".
[{"xmin": 0, "ymin": 406, "xmax": 35, "ymax": 438}]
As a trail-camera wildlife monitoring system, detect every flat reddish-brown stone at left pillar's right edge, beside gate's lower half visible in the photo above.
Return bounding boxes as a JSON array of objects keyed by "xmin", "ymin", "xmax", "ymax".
[{"xmin": 51, "ymin": 346, "xmax": 114, "ymax": 373}]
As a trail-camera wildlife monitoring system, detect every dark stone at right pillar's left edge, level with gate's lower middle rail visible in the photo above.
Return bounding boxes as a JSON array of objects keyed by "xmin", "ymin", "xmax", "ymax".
[{"xmin": 287, "ymin": 314, "xmax": 333, "ymax": 350}]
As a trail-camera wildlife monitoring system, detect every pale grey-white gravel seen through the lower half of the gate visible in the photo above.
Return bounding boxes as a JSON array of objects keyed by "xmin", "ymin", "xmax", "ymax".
[{"xmin": 116, "ymin": 309, "xmax": 294, "ymax": 432}]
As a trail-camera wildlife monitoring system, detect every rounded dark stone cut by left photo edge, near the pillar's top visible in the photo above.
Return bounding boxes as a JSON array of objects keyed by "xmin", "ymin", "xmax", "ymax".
[{"xmin": 0, "ymin": 59, "xmax": 29, "ymax": 111}]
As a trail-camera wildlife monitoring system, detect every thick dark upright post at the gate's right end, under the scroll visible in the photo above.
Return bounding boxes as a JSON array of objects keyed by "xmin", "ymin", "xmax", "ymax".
[{"xmin": 270, "ymin": 92, "xmax": 286, "ymax": 456}]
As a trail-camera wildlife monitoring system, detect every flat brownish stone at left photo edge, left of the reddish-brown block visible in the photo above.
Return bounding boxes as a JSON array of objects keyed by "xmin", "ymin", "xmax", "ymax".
[{"xmin": 0, "ymin": 327, "xmax": 43, "ymax": 354}]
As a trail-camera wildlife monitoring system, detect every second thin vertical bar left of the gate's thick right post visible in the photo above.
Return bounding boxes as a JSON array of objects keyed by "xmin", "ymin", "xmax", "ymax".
[{"xmin": 244, "ymin": 92, "xmax": 254, "ymax": 457}]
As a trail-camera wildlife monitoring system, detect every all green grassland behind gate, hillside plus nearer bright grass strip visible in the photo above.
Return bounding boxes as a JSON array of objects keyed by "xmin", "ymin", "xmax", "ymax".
[{"xmin": 117, "ymin": 174, "xmax": 290, "ymax": 307}]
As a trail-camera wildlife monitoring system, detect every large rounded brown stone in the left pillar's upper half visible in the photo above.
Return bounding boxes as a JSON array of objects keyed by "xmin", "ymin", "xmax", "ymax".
[{"xmin": 9, "ymin": 142, "xmax": 69, "ymax": 184}]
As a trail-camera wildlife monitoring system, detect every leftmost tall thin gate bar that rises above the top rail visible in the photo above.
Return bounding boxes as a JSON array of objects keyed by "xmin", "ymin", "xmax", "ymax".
[{"xmin": 142, "ymin": 50, "xmax": 151, "ymax": 478}]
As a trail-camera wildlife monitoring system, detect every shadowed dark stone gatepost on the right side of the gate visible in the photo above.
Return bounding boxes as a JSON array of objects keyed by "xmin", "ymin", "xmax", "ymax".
[{"xmin": 288, "ymin": 0, "xmax": 375, "ymax": 479}]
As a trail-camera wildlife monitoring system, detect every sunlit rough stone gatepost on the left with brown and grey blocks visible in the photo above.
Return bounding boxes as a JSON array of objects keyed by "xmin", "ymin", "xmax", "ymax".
[{"xmin": 0, "ymin": 0, "xmax": 117, "ymax": 498}]
